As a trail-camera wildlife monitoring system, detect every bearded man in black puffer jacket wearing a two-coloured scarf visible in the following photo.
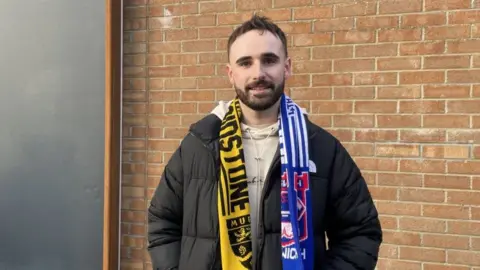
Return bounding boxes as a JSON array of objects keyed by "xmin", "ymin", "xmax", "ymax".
[{"xmin": 148, "ymin": 16, "xmax": 382, "ymax": 270}]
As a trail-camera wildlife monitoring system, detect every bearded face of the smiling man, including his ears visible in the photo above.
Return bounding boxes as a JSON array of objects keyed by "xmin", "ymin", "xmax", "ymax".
[{"xmin": 227, "ymin": 30, "xmax": 291, "ymax": 111}]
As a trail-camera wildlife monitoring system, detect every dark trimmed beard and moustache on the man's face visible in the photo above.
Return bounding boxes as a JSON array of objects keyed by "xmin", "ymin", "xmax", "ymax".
[{"xmin": 234, "ymin": 80, "xmax": 285, "ymax": 111}]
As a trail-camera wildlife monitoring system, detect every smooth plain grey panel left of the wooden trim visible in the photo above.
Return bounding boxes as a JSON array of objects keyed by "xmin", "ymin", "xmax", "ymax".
[{"xmin": 0, "ymin": 0, "xmax": 105, "ymax": 270}]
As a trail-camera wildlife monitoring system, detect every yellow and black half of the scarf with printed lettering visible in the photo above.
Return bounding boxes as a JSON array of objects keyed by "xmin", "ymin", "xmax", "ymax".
[{"xmin": 218, "ymin": 99, "xmax": 252, "ymax": 270}]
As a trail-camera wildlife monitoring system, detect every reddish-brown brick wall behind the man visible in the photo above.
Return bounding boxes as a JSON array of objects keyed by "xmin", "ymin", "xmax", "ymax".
[{"xmin": 121, "ymin": 0, "xmax": 480, "ymax": 270}]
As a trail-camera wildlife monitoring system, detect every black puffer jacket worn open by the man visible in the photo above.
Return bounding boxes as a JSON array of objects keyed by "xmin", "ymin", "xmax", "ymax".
[{"xmin": 148, "ymin": 114, "xmax": 382, "ymax": 270}]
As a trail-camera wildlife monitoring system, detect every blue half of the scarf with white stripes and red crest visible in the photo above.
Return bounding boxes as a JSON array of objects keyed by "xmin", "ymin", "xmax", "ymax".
[{"xmin": 279, "ymin": 94, "xmax": 314, "ymax": 270}]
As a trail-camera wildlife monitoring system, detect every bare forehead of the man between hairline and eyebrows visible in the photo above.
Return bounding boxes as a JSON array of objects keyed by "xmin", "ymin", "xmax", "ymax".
[{"xmin": 230, "ymin": 30, "xmax": 283, "ymax": 62}]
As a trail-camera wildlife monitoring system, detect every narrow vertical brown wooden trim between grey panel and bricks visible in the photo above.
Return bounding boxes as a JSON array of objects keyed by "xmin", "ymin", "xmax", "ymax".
[{"xmin": 103, "ymin": 0, "xmax": 122, "ymax": 270}]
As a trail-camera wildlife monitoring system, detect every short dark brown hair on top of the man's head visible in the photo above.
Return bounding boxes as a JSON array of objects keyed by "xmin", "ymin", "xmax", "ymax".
[{"xmin": 227, "ymin": 14, "xmax": 288, "ymax": 59}]
